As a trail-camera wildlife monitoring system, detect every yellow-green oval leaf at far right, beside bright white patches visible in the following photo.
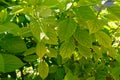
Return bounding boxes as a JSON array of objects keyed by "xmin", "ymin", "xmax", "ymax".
[{"xmin": 95, "ymin": 31, "xmax": 112, "ymax": 48}]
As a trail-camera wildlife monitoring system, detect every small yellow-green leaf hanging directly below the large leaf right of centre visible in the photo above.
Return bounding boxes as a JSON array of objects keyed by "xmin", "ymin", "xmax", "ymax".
[{"xmin": 78, "ymin": 45, "xmax": 90, "ymax": 57}]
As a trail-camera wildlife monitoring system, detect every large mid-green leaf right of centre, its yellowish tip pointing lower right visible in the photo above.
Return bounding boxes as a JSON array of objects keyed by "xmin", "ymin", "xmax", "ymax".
[{"xmin": 74, "ymin": 28, "xmax": 92, "ymax": 48}]
